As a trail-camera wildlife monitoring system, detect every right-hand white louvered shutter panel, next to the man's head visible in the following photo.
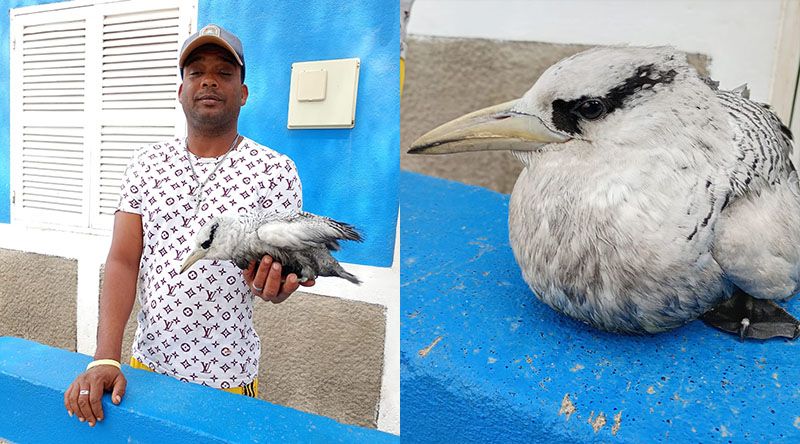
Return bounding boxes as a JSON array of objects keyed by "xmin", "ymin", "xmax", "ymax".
[{"xmin": 91, "ymin": 1, "xmax": 191, "ymax": 228}]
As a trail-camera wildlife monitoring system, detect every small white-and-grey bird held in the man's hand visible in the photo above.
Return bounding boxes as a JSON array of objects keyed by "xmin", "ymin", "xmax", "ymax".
[{"xmin": 180, "ymin": 211, "xmax": 363, "ymax": 284}]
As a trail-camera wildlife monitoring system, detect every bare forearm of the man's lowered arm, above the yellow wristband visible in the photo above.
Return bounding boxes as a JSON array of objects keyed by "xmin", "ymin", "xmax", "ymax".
[{"xmin": 94, "ymin": 257, "xmax": 139, "ymax": 361}]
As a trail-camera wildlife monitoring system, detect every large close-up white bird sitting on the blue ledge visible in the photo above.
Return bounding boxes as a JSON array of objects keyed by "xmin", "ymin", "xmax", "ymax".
[{"xmin": 409, "ymin": 45, "xmax": 800, "ymax": 340}]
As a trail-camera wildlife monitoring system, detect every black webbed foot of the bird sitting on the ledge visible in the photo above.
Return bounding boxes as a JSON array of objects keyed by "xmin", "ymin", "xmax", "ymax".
[{"xmin": 700, "ymin": 288, "xmax": 800, "ymax": 340}]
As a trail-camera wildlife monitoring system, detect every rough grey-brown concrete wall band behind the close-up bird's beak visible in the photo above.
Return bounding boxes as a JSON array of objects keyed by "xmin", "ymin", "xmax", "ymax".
[{"xmin": 400, "ymin": 36, "xmax": 709, "ymax": 193}]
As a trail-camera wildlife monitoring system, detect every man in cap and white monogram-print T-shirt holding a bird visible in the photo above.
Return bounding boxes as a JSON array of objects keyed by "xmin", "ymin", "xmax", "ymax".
[{"xmin": 64, "ymin": 25, "xmax": 314, "ymax": 426}]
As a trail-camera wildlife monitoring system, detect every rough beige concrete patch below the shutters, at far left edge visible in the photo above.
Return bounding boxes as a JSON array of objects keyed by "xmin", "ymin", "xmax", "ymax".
[{"xmin": 0, "ymin": 249, "xmax": 78, "ymax": 351}]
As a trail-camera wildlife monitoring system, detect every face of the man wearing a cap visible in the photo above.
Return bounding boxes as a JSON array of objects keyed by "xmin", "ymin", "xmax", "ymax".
[{"xmin": 178, "ymin": 45, "xmax": 247, "ymax": 132}]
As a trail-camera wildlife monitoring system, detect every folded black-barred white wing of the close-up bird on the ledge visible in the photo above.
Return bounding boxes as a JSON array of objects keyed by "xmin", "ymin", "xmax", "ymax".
[{"xmin": 712, "ymin": 92, "xmax": 800, "ymax": 299}]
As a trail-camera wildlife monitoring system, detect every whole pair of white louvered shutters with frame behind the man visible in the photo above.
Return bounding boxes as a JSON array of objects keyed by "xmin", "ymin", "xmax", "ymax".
[{"xmin": 11, "ymin": 0, "xmax": 196, "ymax": 231}]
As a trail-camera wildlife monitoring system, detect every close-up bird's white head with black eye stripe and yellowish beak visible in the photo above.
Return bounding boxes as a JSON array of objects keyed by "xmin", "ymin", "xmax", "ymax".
[{"xmin": 409, "ymin": 47, "xmax": 712, "ymax": 160}]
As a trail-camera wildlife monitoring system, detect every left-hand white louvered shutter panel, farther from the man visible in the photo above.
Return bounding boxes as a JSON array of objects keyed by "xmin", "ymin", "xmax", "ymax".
[{"xmin": 11, "ymin": 8, "xmax": 90, "ymax": 226}]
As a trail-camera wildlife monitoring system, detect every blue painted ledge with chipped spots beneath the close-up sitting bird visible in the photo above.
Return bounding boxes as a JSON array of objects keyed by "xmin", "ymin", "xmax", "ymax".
[{"xmin": 400, "ymin": 173, "xmax": 800, "ymax": 443}]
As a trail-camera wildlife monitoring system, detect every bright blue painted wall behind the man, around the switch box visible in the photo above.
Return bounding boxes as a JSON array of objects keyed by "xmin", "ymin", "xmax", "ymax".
[{"xmin": 0, "ymin": 0, "xmax": 400, "ymax": 266}]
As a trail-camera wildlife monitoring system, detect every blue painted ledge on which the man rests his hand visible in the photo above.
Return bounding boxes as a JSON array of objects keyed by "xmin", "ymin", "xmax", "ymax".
[{"xmin": 0, "ymin": 337, "xmax": 400, "ymax": 443}]
